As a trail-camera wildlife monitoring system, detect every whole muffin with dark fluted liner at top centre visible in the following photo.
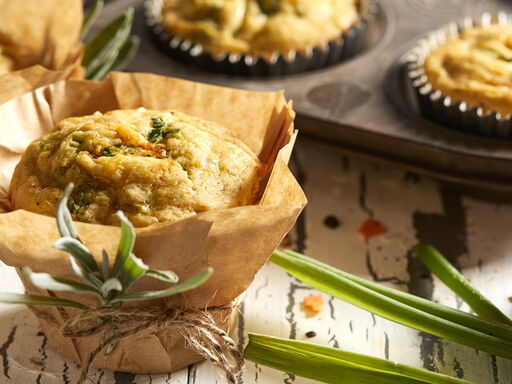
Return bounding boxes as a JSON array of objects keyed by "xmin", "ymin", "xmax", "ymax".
[{"xmin": 146, "ymin": 0, "xmax": 377, "ymax": 76}]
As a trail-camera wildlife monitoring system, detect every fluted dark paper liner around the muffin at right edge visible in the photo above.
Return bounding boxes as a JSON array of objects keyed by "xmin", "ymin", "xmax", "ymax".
[{"xmin": 406, "ymin": 12, "xmax": 512, "ymax": 139}]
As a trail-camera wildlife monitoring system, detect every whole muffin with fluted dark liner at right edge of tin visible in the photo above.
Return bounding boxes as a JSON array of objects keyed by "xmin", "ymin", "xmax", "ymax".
[{"xmin": 407, "ymin": 13, "xmax": 512, "ymax": 139}]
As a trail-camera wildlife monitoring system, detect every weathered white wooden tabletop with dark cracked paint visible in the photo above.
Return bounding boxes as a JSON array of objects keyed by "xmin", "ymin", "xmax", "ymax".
[{"xmin": 0, "ymin": 144, "xmax": 512, "ymax": 384}]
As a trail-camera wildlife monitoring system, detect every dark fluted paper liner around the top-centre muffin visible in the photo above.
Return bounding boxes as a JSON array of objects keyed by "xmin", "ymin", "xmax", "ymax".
[{"xmin": 144, "ymin": 0, "xmax": 379, "ymax": 77}]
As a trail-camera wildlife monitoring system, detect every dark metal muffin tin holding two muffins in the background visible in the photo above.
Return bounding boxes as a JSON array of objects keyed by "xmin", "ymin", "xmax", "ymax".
[{"xmin": 104, "ymin": 0, "xmax": 512, "ymax": 196}]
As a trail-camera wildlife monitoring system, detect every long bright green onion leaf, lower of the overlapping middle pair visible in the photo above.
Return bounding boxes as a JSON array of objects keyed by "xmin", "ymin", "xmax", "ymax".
[{"xmin": 270, "ymin": 251, "xmax": 512, "ymax": 360}]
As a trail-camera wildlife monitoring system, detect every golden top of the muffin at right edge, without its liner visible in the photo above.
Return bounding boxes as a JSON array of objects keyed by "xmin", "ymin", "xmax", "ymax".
[{"xmin": 424, "ymin": 25, "xmax": 512, "ymax": 117}]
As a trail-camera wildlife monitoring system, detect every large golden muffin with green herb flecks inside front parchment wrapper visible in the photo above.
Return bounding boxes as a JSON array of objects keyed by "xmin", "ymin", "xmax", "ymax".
[{"xmin": 11, "ymin": 108, "xmax": 262, "ymax": 226}]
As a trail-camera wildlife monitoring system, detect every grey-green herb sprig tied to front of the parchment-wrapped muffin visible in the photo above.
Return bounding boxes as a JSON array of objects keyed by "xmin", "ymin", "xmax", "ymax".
[{"xmin": 0, "ymin": 184, "xmax": 213, "ymax": 309}]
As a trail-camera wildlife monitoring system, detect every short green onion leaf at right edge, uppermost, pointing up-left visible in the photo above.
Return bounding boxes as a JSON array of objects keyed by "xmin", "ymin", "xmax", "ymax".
[{"xmin": 413, "ymin": 243, "xmax": 512, "ymax": 325}]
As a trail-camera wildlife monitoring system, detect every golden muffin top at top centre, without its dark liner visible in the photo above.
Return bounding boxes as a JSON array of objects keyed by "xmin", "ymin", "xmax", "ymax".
[{"xmin": 162, "ymin": 0, "xmax": 359, "ymax": 57}]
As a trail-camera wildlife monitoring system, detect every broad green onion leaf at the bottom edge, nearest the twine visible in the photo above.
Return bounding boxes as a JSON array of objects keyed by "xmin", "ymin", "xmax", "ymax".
[{"xmin": 244, "ymin": 334, "xmax": 469, "ymax": 384}]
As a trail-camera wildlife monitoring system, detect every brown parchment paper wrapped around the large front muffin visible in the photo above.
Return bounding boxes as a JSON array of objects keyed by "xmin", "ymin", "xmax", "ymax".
[{"xmin": 0, "ymin": 73, "xmax": 306, "ymax": 373}]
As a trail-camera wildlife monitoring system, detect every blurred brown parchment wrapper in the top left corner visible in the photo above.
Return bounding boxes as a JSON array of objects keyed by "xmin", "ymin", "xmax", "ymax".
[{"xmin": 0, "ymin": 0, "xmax": 83, "ymax": 77}]
